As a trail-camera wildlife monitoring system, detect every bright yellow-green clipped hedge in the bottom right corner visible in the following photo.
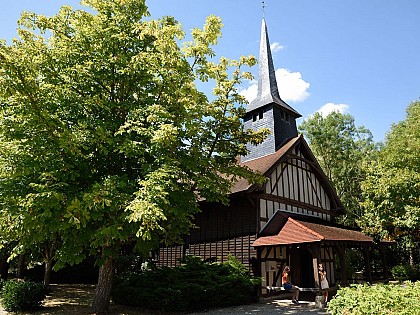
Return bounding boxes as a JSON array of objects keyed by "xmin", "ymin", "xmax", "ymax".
[{"xmin": 328, "ymin": 281, "xmax": 420, "ymax": 315}]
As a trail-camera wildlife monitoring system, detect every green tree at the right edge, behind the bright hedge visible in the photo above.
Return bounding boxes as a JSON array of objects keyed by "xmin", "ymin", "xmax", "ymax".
[{"xmin": 359, "ymin": 101, "xmax": 420, "ymax": 263}]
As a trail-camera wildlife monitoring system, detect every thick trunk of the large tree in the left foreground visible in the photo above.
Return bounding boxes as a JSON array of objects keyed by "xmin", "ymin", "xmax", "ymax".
[{"xmin": 92, "ymin": 257, "xmax": 114, "ymax": 315}]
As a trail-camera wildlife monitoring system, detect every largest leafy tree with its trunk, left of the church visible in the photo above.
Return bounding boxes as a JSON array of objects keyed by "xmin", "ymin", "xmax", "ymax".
[{"xmin": 0, "ymin": 0, "xmax": 266, "ymax": 313}]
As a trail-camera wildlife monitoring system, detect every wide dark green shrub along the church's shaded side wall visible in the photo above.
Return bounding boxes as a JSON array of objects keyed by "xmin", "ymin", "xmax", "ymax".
[{"xmin": 112, "ymin": 256, "xmax": 260, "ymax": 312}]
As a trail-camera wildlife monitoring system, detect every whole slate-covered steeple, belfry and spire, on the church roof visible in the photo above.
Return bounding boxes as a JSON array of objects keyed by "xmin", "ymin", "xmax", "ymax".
[{"xmin": 242, "ymin": 19, "xmax": 301, "ymax": 162}]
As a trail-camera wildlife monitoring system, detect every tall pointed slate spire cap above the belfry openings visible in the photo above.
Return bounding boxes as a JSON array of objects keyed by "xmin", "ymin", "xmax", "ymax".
[{"xmin": 247, "ymin": 18, "xmax": 301, "ymax": 118}]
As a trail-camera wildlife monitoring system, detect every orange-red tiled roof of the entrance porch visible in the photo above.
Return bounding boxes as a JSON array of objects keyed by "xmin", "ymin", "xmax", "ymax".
[{"xmin": 252, "ymin": 217, "xmax": 373, "ymax": 246}]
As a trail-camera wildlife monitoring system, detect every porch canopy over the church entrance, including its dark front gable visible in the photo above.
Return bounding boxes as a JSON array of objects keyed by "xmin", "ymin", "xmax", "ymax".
[{"xmin": 252, "ymin": 210, "xmax": 373, "ymax": 247}]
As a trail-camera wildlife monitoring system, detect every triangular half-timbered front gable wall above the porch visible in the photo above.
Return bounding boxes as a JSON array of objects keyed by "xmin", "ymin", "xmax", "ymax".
[{"xmin": 254, "ymin": 143, "xmax": 342, "ymax": 232}]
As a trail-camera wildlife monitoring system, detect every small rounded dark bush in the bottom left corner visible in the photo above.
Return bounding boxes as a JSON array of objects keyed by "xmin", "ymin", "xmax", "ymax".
[{"xmin": 1, "ymin": 280, "xmax": 47, "ymax": 312}]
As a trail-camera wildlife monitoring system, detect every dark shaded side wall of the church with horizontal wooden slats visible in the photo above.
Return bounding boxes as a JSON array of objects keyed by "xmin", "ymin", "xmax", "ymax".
[{"xmin": 156, "ymin": 196, "xmax": 257, "ymax": 270}]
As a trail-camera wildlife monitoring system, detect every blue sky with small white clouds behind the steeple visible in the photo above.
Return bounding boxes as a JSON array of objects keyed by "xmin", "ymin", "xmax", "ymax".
[{"xmin": 0, "ymin": 0, "xmax": 420, "ymax": 141}]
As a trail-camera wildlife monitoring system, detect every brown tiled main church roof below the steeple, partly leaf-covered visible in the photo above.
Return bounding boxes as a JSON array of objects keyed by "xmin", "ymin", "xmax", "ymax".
[{"xmin": 231, "ymin": 135, "xmax": 302, "ymax": 194}]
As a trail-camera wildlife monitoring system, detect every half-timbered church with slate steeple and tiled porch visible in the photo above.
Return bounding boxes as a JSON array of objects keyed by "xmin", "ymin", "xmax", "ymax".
[{"xmin": 157, "ymin": 19, "xmax": 378, "ymax": 293}]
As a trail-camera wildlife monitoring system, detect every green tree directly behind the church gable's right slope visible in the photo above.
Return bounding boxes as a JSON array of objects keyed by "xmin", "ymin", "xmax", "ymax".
[{"xmin": 299, "ymin": 112, "xmax": 377, "ymax": 226}]
